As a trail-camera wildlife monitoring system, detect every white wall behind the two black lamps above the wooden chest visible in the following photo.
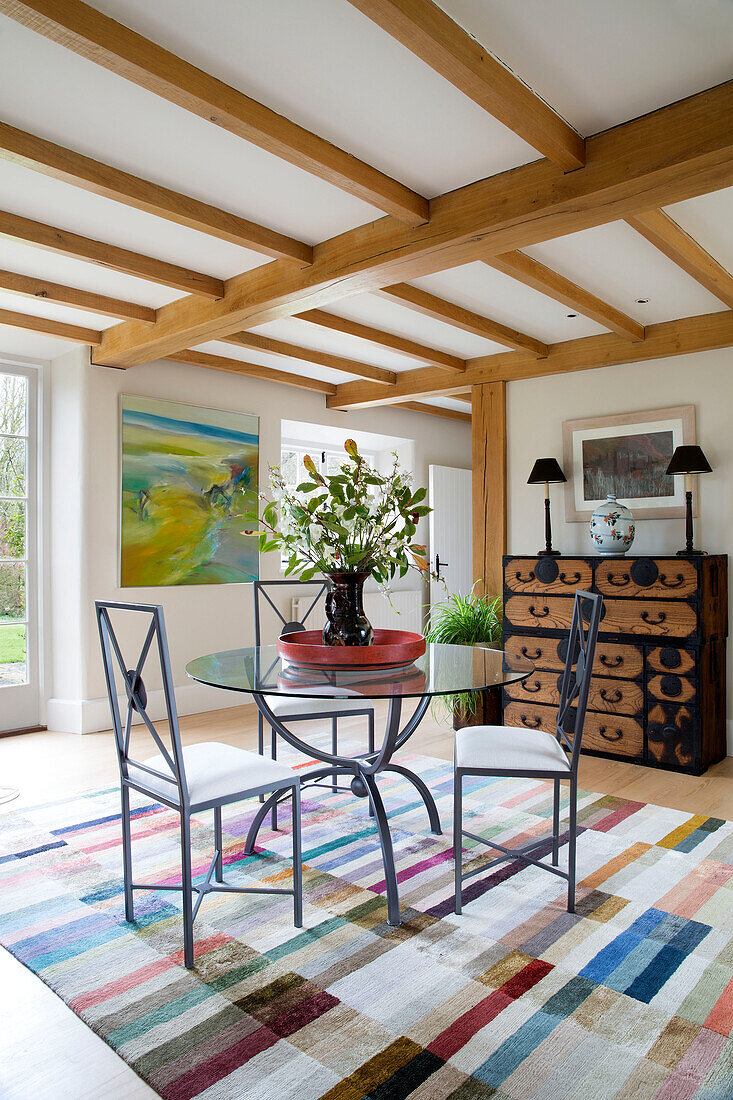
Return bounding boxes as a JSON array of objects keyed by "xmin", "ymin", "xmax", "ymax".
[{"xmin": 507, "ymin": 349, "xmax": 733, "ymax": 755}]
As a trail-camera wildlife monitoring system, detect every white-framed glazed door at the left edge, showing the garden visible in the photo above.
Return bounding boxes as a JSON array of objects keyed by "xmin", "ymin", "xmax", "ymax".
[{"xmin": 0, "ymin": 363, "xmax": 39, "ymax": 730}]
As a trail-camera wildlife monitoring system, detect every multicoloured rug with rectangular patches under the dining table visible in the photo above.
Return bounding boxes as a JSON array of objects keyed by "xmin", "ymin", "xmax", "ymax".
[{"xmin": 0, "ymin": 757, "xmax": 733, "ymax": 1100}]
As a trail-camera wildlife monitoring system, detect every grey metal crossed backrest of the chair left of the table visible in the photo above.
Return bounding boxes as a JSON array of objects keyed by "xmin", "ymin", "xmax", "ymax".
[{"xmin": 95, "ymin": 600, "xmax": 188, "ymax": 806}]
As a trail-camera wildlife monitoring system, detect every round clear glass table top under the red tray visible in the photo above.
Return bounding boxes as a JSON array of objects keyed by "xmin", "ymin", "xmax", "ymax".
[{"xmin": 186, "ymin": 642, "xmax": 534, "ymax": 699}]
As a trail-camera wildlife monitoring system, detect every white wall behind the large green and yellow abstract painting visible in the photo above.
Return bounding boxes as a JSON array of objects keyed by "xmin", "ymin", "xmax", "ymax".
[{"xmin": 46, "ymin": 350, "xmax": 471, "ymax": 732}]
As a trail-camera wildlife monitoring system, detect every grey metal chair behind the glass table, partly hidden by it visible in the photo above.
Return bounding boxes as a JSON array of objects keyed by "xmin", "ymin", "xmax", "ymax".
[{"xmin": 253, "ymin": 580, "xmax": 374, "ymax": 828}]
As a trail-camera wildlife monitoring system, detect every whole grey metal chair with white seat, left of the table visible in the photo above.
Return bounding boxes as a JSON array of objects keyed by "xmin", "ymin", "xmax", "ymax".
[{"xmin": 95, "ymin": 600, "xmax": 303, "ymax": 970}]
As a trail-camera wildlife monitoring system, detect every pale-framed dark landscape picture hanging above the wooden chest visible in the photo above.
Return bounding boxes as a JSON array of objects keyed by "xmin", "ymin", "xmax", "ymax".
[{"xmin": 562, "ymin": 405, "xmax": 696, "ymax": 523}]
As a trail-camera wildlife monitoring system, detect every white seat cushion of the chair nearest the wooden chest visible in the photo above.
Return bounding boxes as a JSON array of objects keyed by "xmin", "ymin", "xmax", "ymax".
[{"xmin": 456, "ymin": 726, "xmax": 570, "ymax": 772}]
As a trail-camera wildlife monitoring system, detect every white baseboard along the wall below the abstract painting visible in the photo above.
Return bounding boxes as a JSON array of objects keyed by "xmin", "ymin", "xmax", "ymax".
[{"xmin": 46, "ymin": 684, "xmax": 252, "ymax": 734}]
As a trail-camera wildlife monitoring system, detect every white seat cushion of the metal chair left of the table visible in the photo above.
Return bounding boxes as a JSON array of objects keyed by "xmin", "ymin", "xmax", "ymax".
[{"xmin": 128, "ymin": 741, "xmax": 296, "ymax": 805}]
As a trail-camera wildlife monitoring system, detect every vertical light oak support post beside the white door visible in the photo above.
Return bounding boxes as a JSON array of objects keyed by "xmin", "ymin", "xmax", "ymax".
[{"xmin": 471, "ymin": 382, "xmax": 506, "ymax": 596}]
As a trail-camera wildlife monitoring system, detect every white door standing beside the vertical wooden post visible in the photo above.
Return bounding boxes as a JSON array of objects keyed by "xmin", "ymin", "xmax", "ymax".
[{"xmin": 428, "ymin": 466, "xmax": 473, "ymax": 604}]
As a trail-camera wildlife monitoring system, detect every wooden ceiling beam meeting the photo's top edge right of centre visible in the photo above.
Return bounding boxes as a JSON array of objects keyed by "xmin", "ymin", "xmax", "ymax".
[{"xmin": 349, "ymin": 0, "xmax": 586, "ymax": 172}]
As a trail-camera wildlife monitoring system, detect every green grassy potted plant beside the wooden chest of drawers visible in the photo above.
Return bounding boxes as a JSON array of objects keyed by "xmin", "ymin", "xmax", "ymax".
[{"xmin": 425, "ymin": 581, "xmax": 503, "ymax": 726}]
